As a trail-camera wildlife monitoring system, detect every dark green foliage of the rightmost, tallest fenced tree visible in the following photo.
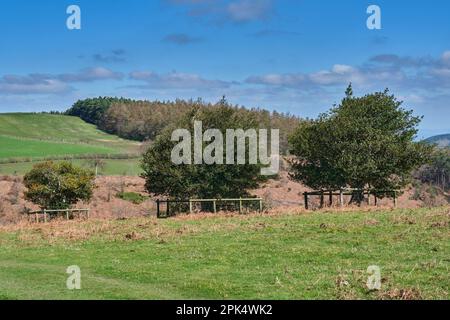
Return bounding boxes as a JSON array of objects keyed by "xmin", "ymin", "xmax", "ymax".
[{"xmin": 290, "ymin": 87, "xmax": 432, "ymax": 190}]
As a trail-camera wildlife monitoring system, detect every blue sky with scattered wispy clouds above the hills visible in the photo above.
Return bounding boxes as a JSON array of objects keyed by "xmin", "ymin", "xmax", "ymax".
[{"xmin": 0, "ymin": 0, "xmax": 450, "ymax": 137}]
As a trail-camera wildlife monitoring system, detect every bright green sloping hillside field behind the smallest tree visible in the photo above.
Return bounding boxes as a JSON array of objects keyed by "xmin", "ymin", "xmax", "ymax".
[{"xmin": 0, "ymin": 113, "xmax": 140, "ymax": 175}]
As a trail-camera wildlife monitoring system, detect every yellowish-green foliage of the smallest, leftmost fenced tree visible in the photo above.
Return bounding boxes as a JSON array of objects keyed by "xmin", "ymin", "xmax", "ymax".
[{"xmin": 24, "ymin": 161, "xmax": 95, "ymax": 209}]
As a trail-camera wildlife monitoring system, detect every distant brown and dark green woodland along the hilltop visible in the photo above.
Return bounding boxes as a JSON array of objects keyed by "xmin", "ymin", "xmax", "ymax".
[{"xmin": 66, "ymin": 97, "xmax": 301, "ymax": 154}]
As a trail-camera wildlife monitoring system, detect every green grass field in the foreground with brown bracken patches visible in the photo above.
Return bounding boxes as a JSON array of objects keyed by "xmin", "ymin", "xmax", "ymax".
[{"xmin": 0, "ymin": 208, "xmax": 450, "ymax": 299}]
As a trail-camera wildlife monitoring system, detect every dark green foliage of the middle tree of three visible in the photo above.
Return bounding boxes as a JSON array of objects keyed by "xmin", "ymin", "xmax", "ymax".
[{"xmin": 142, "ymin": 103, "xmax": 263, "ymax": 199}]
